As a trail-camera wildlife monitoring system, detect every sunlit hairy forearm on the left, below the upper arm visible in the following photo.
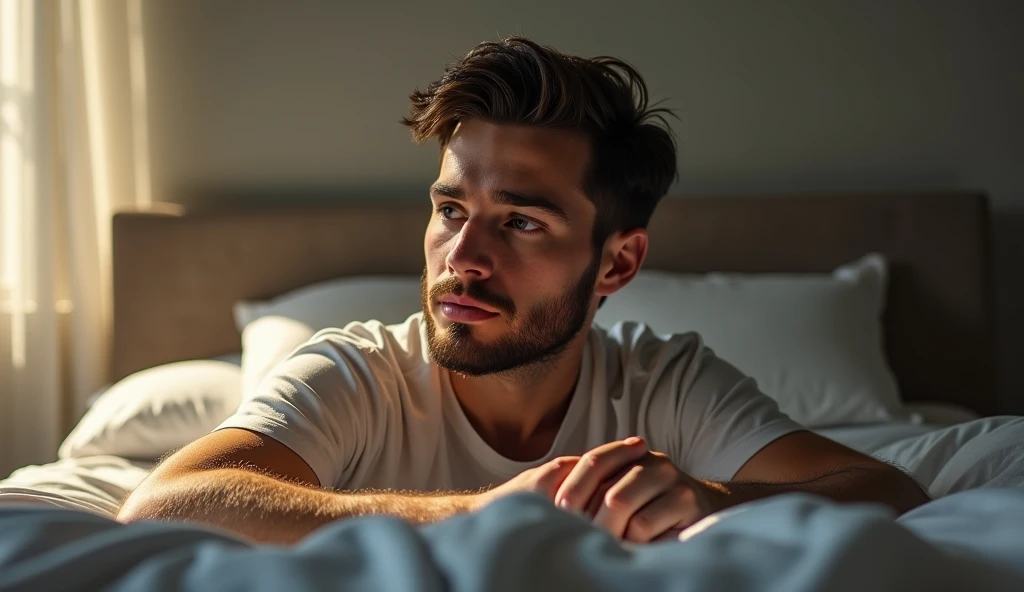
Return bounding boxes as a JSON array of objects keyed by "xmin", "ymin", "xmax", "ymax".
[{"xmin": 118, "ymin": 468, "xmax": 475, "ymax": 543}]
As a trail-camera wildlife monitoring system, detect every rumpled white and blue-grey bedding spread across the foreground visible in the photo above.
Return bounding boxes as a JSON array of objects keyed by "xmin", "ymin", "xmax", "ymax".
[{"xmin": 0, "ymin": 417, "xmax": 1024, "ymax": 591}]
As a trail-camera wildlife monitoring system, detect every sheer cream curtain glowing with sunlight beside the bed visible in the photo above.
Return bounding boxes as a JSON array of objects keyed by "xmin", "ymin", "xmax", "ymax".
[{"xmin": 0, "ymin": 0, "xmax": 150, "ymax": 477}]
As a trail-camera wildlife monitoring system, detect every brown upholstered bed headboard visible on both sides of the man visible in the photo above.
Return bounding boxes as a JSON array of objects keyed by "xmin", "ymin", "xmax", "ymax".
[{"xmin": 112, "ymin": 193, "xmax": 998, "ymax": 414}]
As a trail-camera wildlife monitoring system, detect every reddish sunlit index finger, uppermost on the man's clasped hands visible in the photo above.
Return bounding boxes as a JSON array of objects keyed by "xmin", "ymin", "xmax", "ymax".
[{"xmin": 555, "ymin": 437, "xmax": 648, "ymax": 512}]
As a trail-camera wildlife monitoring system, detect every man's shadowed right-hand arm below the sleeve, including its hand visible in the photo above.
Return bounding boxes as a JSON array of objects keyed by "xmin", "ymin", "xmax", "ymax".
[{"xmin": 555, "ymin": 431, "xmax": 929, "ymax": 542}]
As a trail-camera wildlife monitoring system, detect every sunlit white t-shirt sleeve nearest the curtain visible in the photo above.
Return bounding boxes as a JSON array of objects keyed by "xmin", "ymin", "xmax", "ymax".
[{"xmin": 216, "ymin": 329, "xmax": 392, "ymax": 489}]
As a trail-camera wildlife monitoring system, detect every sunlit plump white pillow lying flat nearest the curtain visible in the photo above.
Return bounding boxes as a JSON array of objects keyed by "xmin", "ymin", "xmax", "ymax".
[{"xmin": 57, "ymin": 360, "xmax": 242, "ymax": 461}]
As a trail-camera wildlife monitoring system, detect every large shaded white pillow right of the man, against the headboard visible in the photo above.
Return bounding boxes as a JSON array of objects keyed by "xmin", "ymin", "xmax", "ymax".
[{"xmin": 595, "ymin": 254, "xmax": 903, "ymax": 427}]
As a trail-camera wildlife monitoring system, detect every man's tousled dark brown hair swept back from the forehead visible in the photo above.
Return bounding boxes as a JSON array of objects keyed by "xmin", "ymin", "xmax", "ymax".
[{"xmin": 401, "ymin": 37, "xmax": 677, "ymax": 247}]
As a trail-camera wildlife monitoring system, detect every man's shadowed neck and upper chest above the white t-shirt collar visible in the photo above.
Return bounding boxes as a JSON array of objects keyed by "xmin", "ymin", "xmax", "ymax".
[{"xmin": 452, "ymin": 330, "xmax": 590, "ymax": 462}]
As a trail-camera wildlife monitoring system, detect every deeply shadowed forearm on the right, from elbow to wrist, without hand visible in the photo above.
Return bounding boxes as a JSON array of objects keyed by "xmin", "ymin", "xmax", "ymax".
[{"xmin": 705, "ymin": 466, "xmax": 931, "ymax": 514}]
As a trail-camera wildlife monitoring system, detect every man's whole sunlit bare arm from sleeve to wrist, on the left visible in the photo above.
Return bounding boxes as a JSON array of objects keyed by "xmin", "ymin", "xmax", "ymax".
[{"xmin": 118, "ymin": 429, "xmax": 481, "ymax": 543}]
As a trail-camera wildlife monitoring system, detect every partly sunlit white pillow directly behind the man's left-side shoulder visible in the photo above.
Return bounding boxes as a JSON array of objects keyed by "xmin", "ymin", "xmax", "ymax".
[{"xmin": 234, "ymin": 276, "xmax": 422, "ymax": 397}]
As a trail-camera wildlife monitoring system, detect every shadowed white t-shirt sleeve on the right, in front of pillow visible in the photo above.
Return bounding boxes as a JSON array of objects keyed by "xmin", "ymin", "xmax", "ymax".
[{"xmin": 674, "ymin": 339, "xmax": 805, "ymax": 481}]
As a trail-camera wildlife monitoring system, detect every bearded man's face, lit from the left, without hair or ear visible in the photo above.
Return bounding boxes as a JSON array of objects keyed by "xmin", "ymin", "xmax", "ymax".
[{"xmin": 422, "ymin": 120, "xmax": 600, "ymax": 376}]
